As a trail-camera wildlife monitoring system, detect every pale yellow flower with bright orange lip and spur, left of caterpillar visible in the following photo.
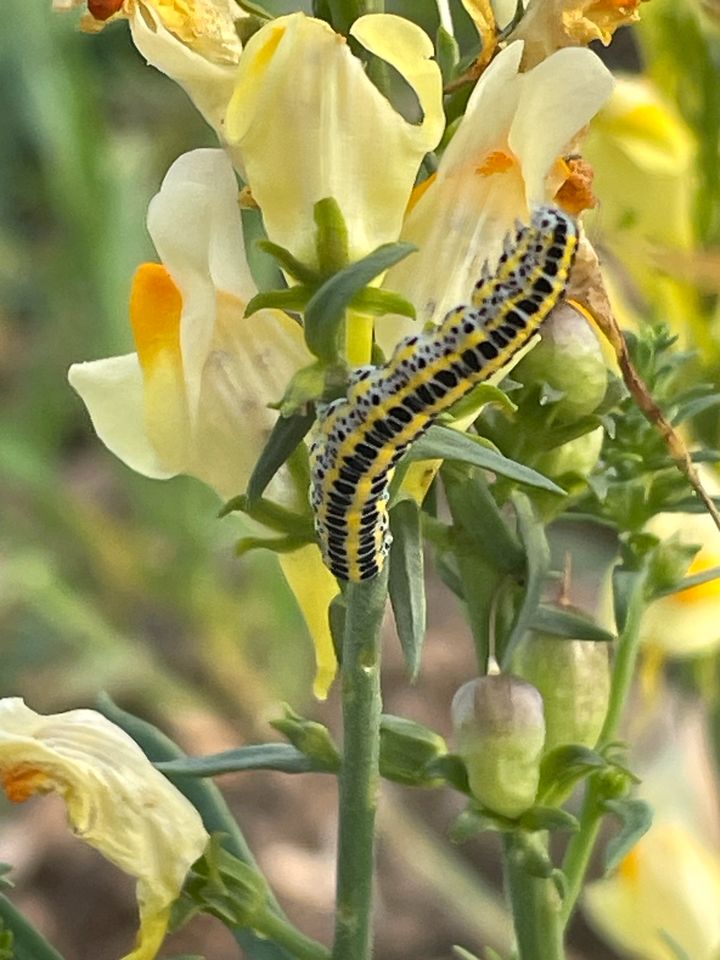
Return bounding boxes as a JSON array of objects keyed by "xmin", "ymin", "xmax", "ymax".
[{"xmin": 69, "ymin": 150, "xmax": 337, "ymax": 695}]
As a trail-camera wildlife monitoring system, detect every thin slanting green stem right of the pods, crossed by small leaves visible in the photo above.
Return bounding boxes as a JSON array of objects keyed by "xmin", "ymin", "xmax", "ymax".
[{"xmin": 562, "ymin": 571, "xmax": 647, "ymax": 926}]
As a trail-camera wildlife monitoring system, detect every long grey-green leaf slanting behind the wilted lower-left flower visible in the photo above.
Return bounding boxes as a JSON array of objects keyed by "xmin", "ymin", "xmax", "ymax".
[{"xmin": 95, "ymin": 693, "xmax": 290, "ymax": 960}]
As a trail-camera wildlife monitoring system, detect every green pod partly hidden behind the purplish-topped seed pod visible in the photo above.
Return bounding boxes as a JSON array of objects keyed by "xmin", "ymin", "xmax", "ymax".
[{"xmin": 513, "ymin": 633, "xmax": 610, "ymax": 751}]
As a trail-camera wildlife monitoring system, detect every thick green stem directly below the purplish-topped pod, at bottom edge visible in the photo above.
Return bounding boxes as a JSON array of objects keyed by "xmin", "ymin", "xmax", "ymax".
[{"xmin": 504, "ymin": 833, "xmax": 565, "ymax": 960}]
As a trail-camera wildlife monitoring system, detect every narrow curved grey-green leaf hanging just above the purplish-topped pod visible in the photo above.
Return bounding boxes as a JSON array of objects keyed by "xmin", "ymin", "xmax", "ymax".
[{"xmin": 500, "ymin": 491, "xmax": 550, "ymax": 669}]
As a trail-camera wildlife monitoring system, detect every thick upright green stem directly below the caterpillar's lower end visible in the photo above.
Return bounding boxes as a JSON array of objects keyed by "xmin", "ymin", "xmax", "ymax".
[{"xmin": 332, "ymin": 566, "xmax": 387, "ymax": 960}]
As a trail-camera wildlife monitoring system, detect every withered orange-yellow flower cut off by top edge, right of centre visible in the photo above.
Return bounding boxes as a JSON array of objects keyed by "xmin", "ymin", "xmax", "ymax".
[{"xmin": 511, "ymin": 0, "xmax": 640, "ymax": 67}]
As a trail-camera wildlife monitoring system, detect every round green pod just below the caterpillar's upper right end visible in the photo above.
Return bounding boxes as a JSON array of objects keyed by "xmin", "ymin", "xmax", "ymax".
[{"xmin": 512, "ymin": 304, "xmax": 607, "ymax": 423}]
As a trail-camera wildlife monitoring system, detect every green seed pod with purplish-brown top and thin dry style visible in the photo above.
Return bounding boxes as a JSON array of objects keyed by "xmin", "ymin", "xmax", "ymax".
[{"xmin": 452, "ymin": 674, "xmax": 545, "ymax": 818}]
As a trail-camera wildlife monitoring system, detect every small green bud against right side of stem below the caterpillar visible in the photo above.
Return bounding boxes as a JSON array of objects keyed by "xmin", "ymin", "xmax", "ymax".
[{"xmin": 380, "ymin": 714, "xmax": 447, "ymax": 787}]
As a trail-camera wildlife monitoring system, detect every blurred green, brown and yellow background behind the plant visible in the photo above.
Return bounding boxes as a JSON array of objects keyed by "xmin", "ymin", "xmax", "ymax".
[{"xmin": 0, "ymin": 0, "xmax": 720, "ymax": 960}]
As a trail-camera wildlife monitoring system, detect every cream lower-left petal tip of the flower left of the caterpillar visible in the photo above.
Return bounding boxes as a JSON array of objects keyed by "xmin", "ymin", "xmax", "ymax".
[{"xmin": 68, "ymin": 353, "xmax": 174, "ymax": 480}]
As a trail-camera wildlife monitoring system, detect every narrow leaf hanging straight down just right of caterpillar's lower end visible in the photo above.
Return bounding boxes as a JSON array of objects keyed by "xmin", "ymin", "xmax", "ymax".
[{"xmin": 388, "ymin": 500, "xmax": 426, "ymax": 681}]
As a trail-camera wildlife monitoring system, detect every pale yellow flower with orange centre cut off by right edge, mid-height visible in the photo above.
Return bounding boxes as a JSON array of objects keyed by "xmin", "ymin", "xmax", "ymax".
[{"xmin": 641, "ymin": 513, "xmax": 720, "ymax": 657}]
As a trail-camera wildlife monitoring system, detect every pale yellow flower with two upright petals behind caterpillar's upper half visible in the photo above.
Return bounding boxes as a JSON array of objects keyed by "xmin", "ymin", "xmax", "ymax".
[{"xmin": 377, "ymin": 42, "xmax": 612, "ymax": 351}]
